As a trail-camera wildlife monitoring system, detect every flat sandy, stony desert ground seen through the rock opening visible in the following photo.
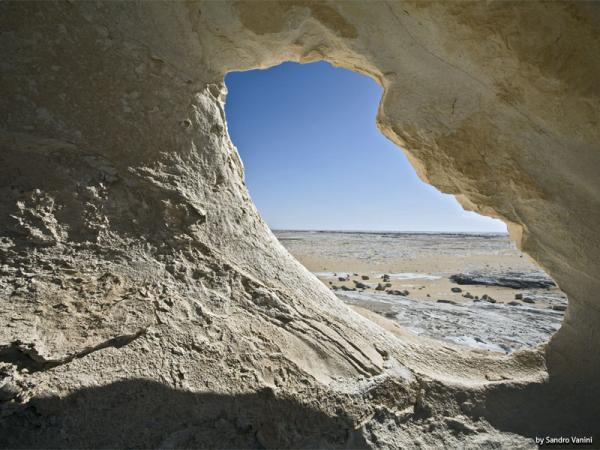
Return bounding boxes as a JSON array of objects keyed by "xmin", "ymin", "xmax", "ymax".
[{"xmin": 276, "ymin": 232, "xmax": 566, "ymax": 353}]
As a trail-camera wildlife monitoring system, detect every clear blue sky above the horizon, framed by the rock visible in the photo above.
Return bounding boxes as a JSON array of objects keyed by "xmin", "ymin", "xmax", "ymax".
[{"xmin": 225, "ymin": 62, "xmax": 506, "ymax": 232}]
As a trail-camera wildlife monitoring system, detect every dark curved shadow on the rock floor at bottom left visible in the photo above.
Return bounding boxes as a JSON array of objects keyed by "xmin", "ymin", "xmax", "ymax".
[{"xmin": 0, "ymin": 379, "xmax": 366, "ymax": 449}]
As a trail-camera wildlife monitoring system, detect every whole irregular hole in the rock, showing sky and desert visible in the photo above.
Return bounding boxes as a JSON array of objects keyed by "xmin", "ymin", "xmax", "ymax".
[{"xmin": 225, "ymin": 61, "xmax": 566, "ymax": 353}]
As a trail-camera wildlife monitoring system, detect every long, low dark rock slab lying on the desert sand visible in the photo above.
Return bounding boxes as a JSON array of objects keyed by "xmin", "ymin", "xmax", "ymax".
[{"xmin": 450, "ymin": 272, "xmax": 556, "ymax": 289}]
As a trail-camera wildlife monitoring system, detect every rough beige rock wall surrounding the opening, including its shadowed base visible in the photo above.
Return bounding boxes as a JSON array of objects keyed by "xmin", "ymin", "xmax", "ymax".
[{"xmin": 0, "ymin": 1, "xmax": 600, "ymax": 448}]
